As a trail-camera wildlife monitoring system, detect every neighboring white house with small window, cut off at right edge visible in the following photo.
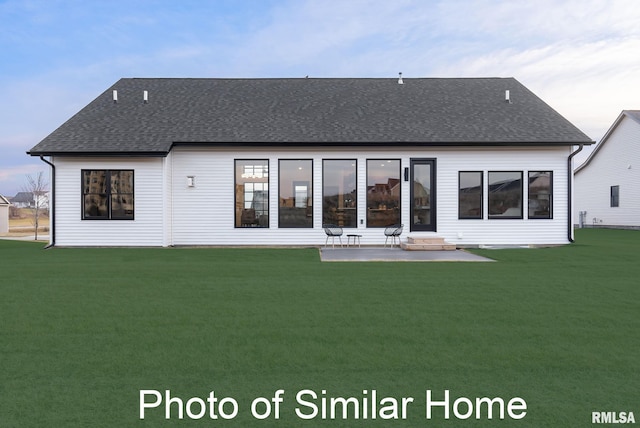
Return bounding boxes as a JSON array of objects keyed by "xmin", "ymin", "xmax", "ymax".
[{"xmin": 574, "ymin": 110, "xmax": 640, "ymax": 228}]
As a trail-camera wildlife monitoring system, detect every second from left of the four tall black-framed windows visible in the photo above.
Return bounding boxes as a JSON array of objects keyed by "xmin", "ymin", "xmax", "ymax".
[{"xmin": 278, "ymin": 160, "xmax": 313, "ymax": 227}]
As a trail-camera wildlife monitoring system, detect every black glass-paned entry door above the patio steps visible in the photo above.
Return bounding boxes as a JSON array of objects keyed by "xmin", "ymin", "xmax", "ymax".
[{"xmin": 411, "ymin": 159, "xmax": 436, "ymax": 231}]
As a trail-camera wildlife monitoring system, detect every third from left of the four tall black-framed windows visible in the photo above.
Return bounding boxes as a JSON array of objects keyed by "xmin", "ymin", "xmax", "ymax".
[{"xmin": 322, "ymin": 159, "xmax": 358, "ymax": 227}]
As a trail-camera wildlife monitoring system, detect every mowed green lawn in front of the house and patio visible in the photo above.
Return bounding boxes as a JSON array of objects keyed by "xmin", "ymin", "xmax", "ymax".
[{"xmin": 0, "ymin": 230, "xmax": 640, "ymax": 427}]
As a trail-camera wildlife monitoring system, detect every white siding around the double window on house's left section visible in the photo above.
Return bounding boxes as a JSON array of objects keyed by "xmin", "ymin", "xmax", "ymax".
[{"xmin": 53, "ymin": 158, "xmax": 164, "ymax": 246}]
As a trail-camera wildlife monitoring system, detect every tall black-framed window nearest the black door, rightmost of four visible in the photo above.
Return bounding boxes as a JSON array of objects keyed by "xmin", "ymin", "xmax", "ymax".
[{"xmin": 367, "ymin": 159, "xmax": 400, "ymax": 227}]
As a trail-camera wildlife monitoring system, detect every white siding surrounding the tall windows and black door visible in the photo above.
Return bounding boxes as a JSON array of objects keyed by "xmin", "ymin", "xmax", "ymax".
[{"xmin": 170, "ymin": 147, "xmax": 571, "ymax": 245}]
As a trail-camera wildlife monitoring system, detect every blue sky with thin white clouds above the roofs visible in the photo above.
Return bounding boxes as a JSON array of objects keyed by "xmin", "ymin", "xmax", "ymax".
[{"xmin": 0, "ymin": 0, "xmax": 640, "ymax": 196}]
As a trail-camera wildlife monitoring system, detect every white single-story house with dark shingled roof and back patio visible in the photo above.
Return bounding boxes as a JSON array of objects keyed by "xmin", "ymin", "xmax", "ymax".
[{"xmin": 28, "ymin": 77, "xmax": 593, "ymax": 246}]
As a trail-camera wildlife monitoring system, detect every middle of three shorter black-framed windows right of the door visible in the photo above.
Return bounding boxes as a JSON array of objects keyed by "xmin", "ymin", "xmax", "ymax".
[{"xmin": 489, "ymin": 171, "xmax": 522, "ymax": 218}]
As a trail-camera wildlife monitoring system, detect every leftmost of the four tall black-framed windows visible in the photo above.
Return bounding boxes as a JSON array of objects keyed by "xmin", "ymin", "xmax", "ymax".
[{"xmin": 235, "ymin": 159, "xmax": 269, "ymax": 227}]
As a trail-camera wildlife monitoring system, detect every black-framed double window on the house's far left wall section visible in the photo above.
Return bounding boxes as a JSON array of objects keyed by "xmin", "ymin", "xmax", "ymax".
[{"xmin": 82, "ymin": 169, "xmax": 134, "ymax": 220}]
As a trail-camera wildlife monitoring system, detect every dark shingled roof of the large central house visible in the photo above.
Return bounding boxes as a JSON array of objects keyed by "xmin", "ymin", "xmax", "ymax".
[{"xmin": 29, "ymin": 78, "xmax": 593, "ymax": 156}]
